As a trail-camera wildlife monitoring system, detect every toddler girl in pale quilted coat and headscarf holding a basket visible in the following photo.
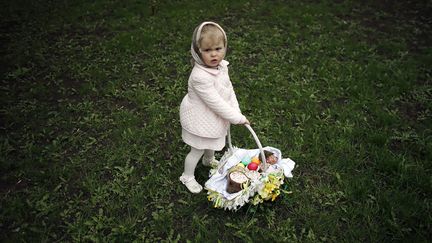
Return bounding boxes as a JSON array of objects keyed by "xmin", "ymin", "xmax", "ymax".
[{"xmin": 180, "ymin": 22, "xmax": 249, "ymax": 193}]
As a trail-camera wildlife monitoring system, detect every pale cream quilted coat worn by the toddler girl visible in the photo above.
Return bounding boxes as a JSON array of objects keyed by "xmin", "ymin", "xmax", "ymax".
[{"xmin": 180, "ymin": 60, "xmax": 246, "ymax": 138}]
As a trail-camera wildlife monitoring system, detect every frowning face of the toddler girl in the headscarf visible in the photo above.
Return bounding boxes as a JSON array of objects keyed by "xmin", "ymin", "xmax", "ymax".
[{"xmin": 200, "ymin": 37, "xmax": 225, "ymax": 68}]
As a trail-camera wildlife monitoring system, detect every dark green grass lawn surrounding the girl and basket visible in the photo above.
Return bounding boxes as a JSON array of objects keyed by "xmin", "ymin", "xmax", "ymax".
[{"xmin": 0, "ymin": 0, "xmax": 432, "ymax": 242}]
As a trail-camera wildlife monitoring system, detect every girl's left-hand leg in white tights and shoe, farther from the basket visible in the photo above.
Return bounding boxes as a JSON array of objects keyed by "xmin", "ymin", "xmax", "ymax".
[{"xmin": 180, "ymin": 147, "xmax": 204, "ymax": 193}]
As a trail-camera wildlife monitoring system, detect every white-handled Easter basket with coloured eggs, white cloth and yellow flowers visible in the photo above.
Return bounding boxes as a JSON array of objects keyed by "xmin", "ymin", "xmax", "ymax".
[{"xmin": 205, "ymin": 125, "xmax": 295, "ymax": 211}]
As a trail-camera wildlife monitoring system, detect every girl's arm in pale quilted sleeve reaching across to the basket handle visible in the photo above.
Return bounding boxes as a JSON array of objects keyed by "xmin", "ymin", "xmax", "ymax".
[{"xmin": 192, "ymin": 78, "xmax": 247, "ymax": 124}]
